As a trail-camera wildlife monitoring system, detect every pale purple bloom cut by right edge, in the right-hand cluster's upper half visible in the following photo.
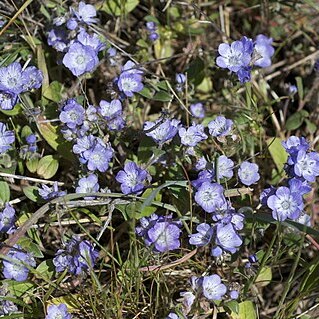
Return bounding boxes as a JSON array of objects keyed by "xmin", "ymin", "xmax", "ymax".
[{"xmin": 294, "ymin": 151, "xmax": 319, "ymax": 182}]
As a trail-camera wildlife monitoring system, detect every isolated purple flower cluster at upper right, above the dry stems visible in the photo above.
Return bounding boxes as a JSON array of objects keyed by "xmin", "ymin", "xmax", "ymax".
[{"xmin": 216, "ymin": 34, "xmax": 275, "ymax": 83}]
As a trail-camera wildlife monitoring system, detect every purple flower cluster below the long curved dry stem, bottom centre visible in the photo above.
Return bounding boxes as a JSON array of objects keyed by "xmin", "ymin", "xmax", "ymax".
[{"xmin": 136, "ymin": 214, "xmax": 182, "ymax": 253}]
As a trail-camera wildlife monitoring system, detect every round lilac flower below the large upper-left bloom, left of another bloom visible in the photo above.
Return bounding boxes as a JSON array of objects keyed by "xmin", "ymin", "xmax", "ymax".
[{"xmin": 59, "ymin": 99, "xmax": 85, "ymax": 129}]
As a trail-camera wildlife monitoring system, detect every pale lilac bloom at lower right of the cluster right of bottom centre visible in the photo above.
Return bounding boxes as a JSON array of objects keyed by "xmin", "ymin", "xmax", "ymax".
[{"xmin": 214, "ymin": 223, "xmax": 243, "ymax": 257}]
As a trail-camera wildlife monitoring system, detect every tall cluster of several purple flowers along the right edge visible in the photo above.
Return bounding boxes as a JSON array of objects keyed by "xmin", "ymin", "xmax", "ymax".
[{"xmin": 260, "ymin": 136, "xmax": 319, "ymax": 221}]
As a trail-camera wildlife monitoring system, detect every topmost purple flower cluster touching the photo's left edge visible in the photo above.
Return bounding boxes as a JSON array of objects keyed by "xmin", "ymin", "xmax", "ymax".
[{"xmin": 0, "ymin": 62, "xmax": 43, "ymax": 110}]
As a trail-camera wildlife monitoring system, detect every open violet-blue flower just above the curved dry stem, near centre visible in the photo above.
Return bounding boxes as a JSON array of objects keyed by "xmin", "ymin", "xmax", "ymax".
[{"xmin": 115, "ymin": 162, "xmax": 150, "ymax": 195}]
